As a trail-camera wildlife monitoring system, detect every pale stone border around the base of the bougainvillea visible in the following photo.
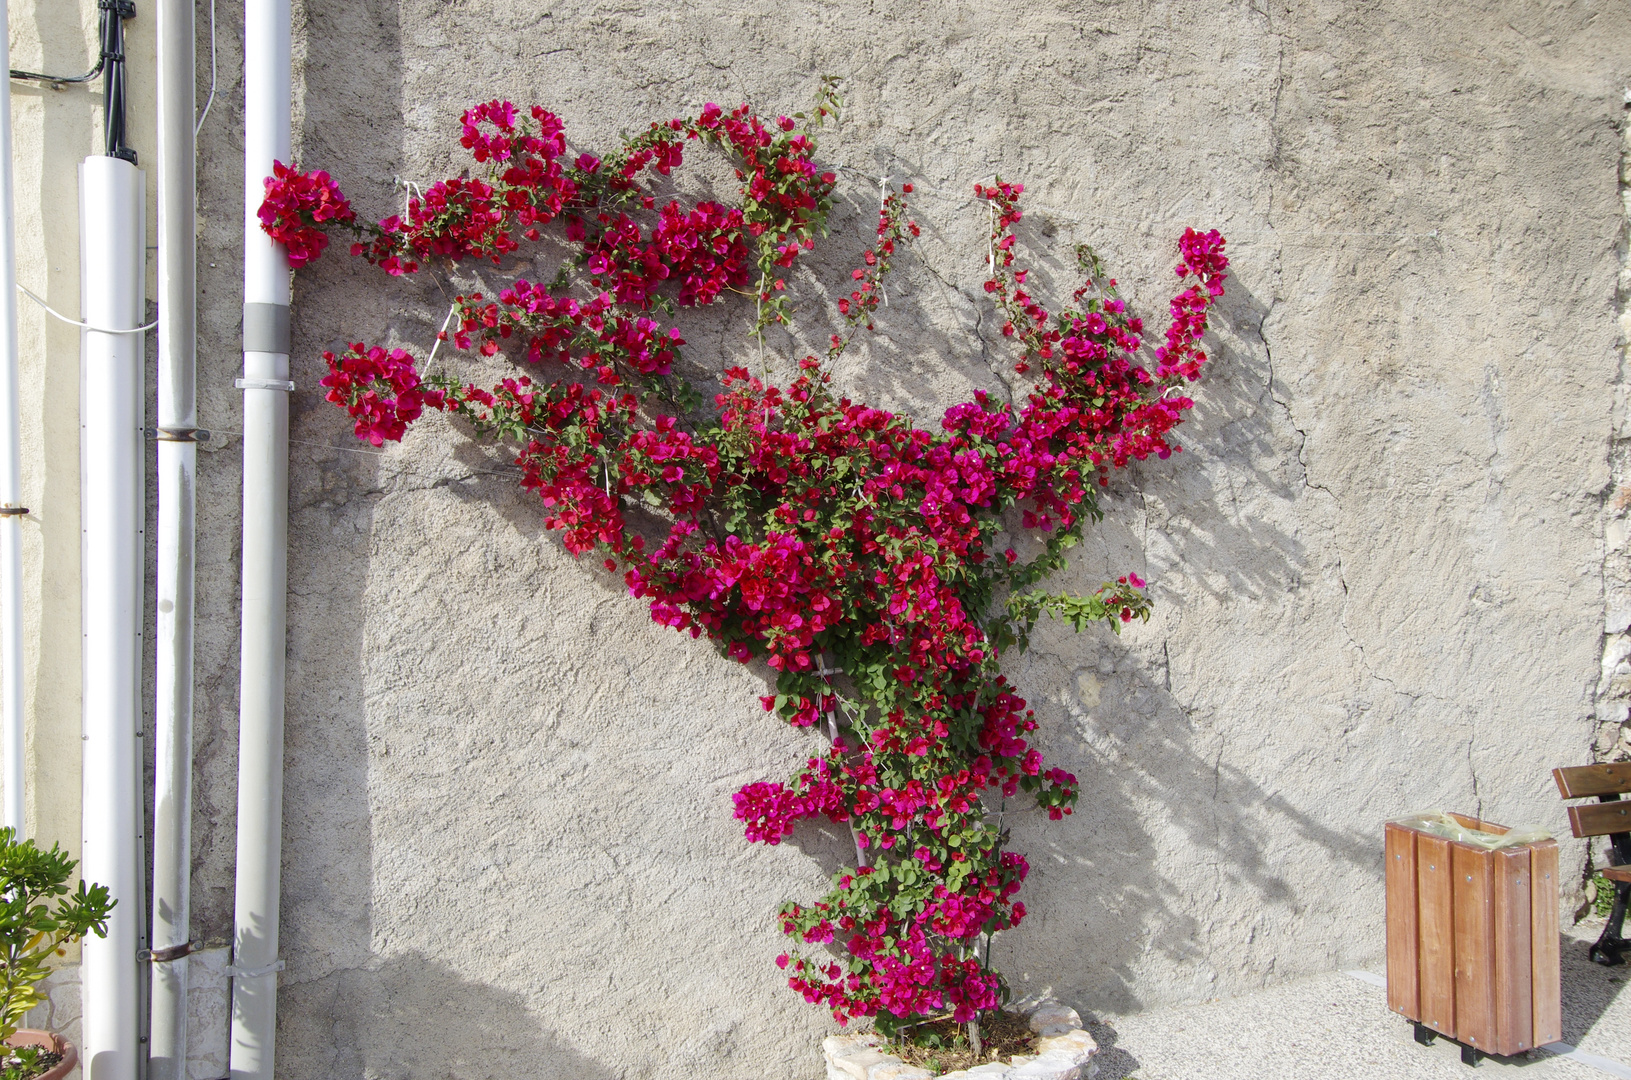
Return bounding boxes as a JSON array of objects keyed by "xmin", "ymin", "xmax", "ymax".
[{"xmin": 820, "ymin": 997, "xmax": 1099, "ymax": 1080}]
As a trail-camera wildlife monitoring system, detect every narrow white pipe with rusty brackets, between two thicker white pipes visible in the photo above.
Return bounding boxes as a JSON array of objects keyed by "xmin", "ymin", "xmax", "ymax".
[{"xmin": 147, "ymin": 0, "xmax": 197, "ymax": 1080}]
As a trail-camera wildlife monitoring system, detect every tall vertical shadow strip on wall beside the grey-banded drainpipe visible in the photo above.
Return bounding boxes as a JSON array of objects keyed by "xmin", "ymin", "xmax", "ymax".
[{"xmin": 272, "ymin": 0, "xmax": 399, "ymax": 1080}]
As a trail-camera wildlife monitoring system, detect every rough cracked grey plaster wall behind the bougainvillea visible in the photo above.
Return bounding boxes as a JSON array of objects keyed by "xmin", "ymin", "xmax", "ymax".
[{"xmin": 181, "ymin": 0, "xmax": 1631, "ymax": 1080}]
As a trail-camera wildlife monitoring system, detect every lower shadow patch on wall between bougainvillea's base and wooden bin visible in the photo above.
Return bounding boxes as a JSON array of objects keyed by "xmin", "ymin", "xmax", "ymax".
[{"xmin": 997, "ymin": 653, "xmax": 1380, "ymax": 1013}]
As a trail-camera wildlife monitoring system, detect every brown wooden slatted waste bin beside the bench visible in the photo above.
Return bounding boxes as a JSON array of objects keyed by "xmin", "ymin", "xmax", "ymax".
[{"xmin": 1386, "ymin": 814, "xmax": 1562, "ymax": 1056}]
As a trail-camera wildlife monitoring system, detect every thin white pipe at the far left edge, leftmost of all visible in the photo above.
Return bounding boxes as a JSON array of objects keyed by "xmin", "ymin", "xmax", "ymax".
[{"xmin": 0, "ymin": 0, "xmax": 26, "ymax": 837}]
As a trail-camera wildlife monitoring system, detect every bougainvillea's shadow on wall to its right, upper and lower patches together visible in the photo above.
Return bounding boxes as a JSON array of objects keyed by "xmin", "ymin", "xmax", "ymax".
[{"xmin": 995, "ymin": 281, "xmax": 1380, "ymax": 1013}]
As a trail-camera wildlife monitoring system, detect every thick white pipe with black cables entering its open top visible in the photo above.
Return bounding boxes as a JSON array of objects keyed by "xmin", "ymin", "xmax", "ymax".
[{"xmin": 80, "ymin": 157, "xmax": 147, "ymax": 1080}]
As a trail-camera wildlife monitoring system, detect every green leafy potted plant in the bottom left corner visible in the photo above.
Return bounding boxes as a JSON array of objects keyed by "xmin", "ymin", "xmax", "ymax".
[{"xmin": 0, "ymin": 829, "xmax": 114, "ymax": 1080}]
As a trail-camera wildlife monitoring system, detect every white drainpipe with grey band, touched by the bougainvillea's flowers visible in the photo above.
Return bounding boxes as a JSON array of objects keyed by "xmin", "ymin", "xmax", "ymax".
[{"xmin": 230, "ymin": 0, "xmax": 294, "ymax": 1080}]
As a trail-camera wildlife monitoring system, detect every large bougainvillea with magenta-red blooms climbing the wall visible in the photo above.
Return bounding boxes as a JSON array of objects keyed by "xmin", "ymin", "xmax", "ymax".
[{"xmin": 261, "ymin": 80, "xmax": 1228, "ymax": 1029}]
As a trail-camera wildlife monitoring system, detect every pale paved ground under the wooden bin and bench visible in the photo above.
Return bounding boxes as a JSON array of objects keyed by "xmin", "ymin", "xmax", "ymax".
[{"xmin": 1088, "ymin": 920, "xmax": 1631, "ymax": 1080}]
